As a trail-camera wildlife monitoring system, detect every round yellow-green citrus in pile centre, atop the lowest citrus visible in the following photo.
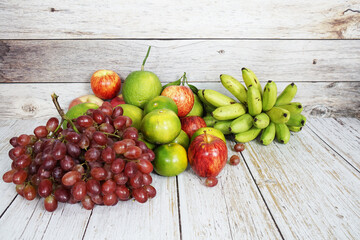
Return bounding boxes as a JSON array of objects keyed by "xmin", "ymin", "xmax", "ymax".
[{"xmin": 140, "ymin": 108, "xmax": 181, "ymax": 144}]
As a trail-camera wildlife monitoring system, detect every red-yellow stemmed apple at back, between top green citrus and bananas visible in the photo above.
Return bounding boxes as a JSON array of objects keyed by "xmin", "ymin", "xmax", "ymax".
[{"xmin": 161, "ymin": 85, "xmax": 195, "ymax": 117}]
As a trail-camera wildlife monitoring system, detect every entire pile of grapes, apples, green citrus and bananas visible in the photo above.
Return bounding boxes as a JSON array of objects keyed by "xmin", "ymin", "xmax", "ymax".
[{"xmin": 3, "ymin": 47, "xmax": 306, "ymax": 211}]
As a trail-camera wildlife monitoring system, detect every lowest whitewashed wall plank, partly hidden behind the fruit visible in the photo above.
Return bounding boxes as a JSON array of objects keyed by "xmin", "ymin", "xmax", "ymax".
[{"xmin": 0, "ymin": 82, "xmax": 360, "ymax": 122}]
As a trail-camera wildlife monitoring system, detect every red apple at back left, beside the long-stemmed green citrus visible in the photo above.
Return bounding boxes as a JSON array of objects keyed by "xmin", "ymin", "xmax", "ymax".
[{"xmin": 90, "ymin": 70, "xmax": 121, "ymax": 100}]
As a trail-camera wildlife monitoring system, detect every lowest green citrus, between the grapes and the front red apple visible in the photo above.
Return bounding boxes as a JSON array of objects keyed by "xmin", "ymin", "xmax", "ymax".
[{"xmin": 153, "ymin": 143, "xmax": 188, "ymax": 177}]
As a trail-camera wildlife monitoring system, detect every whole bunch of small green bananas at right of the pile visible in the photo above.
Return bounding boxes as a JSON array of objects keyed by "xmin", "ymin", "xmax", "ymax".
[{"xmin": 198, "ymin": 68, "xmax": 306, "ymax": 145}]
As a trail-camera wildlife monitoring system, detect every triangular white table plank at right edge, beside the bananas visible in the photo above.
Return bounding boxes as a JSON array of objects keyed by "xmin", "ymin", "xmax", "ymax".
[{"xmin": 308, "ymin": 118, "xmax": 360, "ymax": 171}]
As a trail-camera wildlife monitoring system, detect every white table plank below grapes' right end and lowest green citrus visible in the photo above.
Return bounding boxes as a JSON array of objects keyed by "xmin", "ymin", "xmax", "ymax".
[{"xmin": 84, "ymin": 174, "xmax": 181, "ymax": 239}]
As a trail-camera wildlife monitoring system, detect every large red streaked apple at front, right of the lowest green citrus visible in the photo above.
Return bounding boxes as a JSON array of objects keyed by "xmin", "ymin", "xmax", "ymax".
[{"xmin": 188, "ymin": 133, "xmax": 228, "ymax": 177}]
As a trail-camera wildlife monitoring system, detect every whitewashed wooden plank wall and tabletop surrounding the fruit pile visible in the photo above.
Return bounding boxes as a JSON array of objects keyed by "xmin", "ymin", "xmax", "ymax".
[{"xmin": 0, "ymin": 0, "xmax": 360, "ymax": 239}]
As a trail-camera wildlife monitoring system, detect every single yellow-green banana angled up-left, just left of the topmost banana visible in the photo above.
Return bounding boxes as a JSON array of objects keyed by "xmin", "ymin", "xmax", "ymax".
[{"xmin": 220, "ymin": 74, "xmax": 247, "ymax": 104}]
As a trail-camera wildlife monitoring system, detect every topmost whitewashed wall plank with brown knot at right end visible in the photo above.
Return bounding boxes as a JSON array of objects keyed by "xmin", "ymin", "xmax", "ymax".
[{"xmin": 0, "ymin": 0, "xmax": 360, "ymax": 39}]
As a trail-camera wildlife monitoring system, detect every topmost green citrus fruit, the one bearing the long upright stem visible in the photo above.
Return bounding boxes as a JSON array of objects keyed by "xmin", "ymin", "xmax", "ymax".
[{"xmin": 122, "ymin": 71, "xmax": 162, "ymax": 108}]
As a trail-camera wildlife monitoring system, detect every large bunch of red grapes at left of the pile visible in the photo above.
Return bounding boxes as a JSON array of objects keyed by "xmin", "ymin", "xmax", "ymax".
[{"xmin": 3, "ymin": 102, "xmax": 156, "ymax": 212}]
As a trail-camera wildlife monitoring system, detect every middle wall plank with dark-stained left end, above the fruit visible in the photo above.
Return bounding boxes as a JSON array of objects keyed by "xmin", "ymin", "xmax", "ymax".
[{"xmin": 0, "ymin": 39, "xmax": 360, "ymax": 82}]
